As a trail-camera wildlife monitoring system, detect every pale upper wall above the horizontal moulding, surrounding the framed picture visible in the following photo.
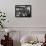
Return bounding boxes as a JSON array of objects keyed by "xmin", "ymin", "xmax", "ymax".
[{"xmin": 0, "ymin": 0, "xmax": 46, "ymax": 27}]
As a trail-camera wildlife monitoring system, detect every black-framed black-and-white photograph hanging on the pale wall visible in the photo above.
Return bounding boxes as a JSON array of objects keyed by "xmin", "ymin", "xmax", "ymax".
[{"xmin": 15, "ymin": 5, "xmax": 32, "ymax": 17}]
